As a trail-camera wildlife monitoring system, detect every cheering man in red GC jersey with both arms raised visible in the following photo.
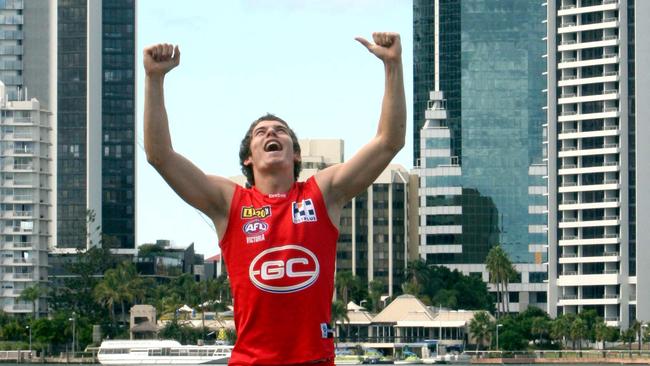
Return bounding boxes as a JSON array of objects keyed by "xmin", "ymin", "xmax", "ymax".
[{"xmin": 144, "ymin": 33, "xmax": 406, "ymax": 365}]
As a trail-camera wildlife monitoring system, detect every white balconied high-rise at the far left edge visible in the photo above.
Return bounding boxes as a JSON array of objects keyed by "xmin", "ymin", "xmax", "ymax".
[{"xmin": 0, "ymin": 83, "xmax": 54, "ymax": 314}]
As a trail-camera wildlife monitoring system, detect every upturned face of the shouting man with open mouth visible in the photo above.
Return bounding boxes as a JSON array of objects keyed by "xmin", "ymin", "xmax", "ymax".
[{"xmin": 244, "ymin": 121, "xmax": 300, "ymax": 174}]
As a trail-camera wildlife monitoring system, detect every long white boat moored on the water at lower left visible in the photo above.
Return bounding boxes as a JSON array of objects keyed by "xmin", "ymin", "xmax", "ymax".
[{"xmin": 97, "ymin": 340, "xmax": 233, "ymax": 366}]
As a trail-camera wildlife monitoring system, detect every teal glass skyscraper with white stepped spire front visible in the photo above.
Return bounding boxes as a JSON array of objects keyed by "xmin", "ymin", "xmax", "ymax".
[{"xmin": 413, "ymin": 0, "xmax": 546, "ymax": 311}]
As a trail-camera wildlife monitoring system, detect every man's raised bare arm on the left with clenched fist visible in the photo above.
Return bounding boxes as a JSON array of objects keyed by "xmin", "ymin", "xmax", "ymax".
[{"xmin": 143, "ymin": 44, "xmax": 235, "ymax": 234}]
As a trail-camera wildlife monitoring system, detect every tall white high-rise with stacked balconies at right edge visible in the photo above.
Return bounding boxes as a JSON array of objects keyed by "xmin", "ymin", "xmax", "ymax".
[{"xmin": 545, "ymin": 0, "xmax": 650, "ymax": 328}]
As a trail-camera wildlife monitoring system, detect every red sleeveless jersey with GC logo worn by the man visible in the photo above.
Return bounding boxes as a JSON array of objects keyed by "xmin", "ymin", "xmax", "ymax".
[{"xmin": 219, "ymin": 177, "xmax": 338, "ymax": 365}]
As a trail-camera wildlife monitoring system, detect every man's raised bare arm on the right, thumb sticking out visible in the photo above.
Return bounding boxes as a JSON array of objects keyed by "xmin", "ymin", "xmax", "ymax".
[{"xmin": 316, "ymin": 33, "xmax": 406, "ymax": 214}]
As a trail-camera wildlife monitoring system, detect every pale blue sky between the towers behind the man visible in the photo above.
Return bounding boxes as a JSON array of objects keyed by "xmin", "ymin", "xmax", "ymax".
[{"xmin": 136, "ymin": 0, "xmax": 413, "ymax": 258}]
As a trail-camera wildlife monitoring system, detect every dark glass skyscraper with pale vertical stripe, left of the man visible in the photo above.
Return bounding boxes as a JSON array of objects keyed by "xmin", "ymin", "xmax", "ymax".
[{"xmin": 56, "ymin": 0, "xmax": 135, "ymax": 250}]
